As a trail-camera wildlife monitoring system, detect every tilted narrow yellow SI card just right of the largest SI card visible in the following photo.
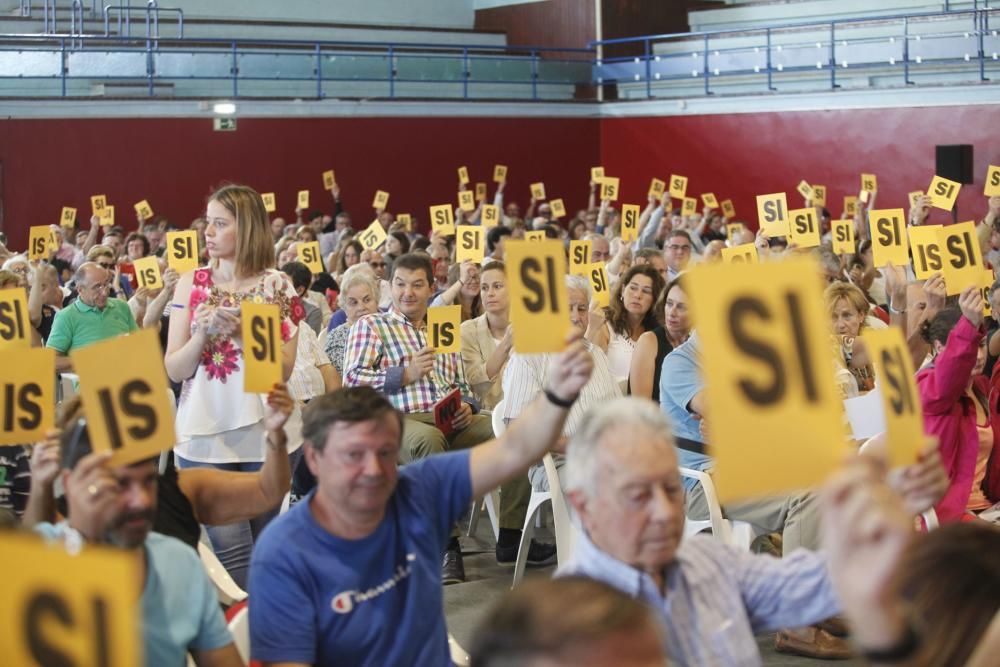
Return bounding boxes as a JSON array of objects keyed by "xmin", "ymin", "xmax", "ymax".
[{"xmin": 864, "ymin": 327, "xmax": 924, "ymax": 468}]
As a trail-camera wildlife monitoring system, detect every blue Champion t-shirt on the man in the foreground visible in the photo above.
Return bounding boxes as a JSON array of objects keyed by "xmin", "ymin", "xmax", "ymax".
[{"xmin": 249, "ymin": 451, "xmax": 472, "ymax": 667}]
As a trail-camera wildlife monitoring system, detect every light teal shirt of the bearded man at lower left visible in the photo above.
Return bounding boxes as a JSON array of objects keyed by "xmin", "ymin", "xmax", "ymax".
[{"xmin": 35, "ymin": 522, "xmax": 233, "ymax": 667}]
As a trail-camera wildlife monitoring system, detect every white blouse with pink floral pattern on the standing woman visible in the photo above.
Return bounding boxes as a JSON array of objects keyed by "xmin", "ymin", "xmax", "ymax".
[{"xmin": 177, "ymin": 268, "xmax": 305, "ymax": 462}]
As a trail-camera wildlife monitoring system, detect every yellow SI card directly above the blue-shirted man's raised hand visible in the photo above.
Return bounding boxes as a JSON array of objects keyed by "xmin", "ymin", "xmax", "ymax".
[{"xmin": 504, "ymin": 240, "xmax": 572, "ymax": 354}]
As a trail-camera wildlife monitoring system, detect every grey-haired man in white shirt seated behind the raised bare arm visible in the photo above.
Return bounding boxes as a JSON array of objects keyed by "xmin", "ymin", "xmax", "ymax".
[{"xmin": 503, "ymin": 276, "xmax": 622, "ymax": 491}]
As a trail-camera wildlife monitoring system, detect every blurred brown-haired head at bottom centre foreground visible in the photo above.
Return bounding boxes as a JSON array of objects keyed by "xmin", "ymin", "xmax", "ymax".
[{"xmin": 469, "ymin": 577, "xmax": 658, "ymax": 667}]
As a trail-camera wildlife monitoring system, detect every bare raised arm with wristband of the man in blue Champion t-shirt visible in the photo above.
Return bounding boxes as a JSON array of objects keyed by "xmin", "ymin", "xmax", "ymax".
[{"xmin": 469, "ymin": 334, "xmax": 594, "ymax": 497}]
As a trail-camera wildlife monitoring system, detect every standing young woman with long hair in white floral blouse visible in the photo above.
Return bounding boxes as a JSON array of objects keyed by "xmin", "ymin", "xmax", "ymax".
[{"xmin": 166, "ymin": 185, "xmax": 305, "ymax": 587}]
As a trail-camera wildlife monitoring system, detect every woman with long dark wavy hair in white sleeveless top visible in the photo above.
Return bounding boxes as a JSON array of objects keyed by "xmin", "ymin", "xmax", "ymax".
[{"xmin": 587, "ymin": 264, "xmax": 664, "ymax": 386}]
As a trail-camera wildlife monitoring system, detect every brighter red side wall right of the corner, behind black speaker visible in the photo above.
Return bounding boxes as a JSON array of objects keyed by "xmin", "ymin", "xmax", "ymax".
[{"xmin": 601, "ymin": 105, "xmax": 1000, "ymax": 227}]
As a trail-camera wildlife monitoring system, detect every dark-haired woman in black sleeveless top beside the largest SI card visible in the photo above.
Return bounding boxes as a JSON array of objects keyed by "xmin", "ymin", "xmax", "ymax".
[{"xmin": 628, "ymin": 276, "xmax": 691, "ymax": 403}]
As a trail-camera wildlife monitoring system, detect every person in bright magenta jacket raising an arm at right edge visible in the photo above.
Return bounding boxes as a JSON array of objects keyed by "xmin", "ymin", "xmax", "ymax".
[{"xmin": 917, "ymin": 287, "xmax": 1000, "ymax": 522}]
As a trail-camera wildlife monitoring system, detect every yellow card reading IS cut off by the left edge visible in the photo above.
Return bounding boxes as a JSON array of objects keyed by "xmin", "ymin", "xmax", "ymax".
[{"xmin": 0, "ymin": 348, "xmax": 56, "ymax": 446}]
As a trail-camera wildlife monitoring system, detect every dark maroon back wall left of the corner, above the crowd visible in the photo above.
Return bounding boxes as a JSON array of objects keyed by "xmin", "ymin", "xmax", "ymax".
[{"xmin": 0, "ymin": 118, "xmax": 600, "ymax": 249}]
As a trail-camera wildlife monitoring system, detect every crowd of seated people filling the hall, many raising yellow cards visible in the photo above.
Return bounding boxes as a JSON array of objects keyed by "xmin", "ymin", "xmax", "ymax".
[{"xmin": 0, "ymin": 181, "xmax": 1000, "ymax": 667}]
